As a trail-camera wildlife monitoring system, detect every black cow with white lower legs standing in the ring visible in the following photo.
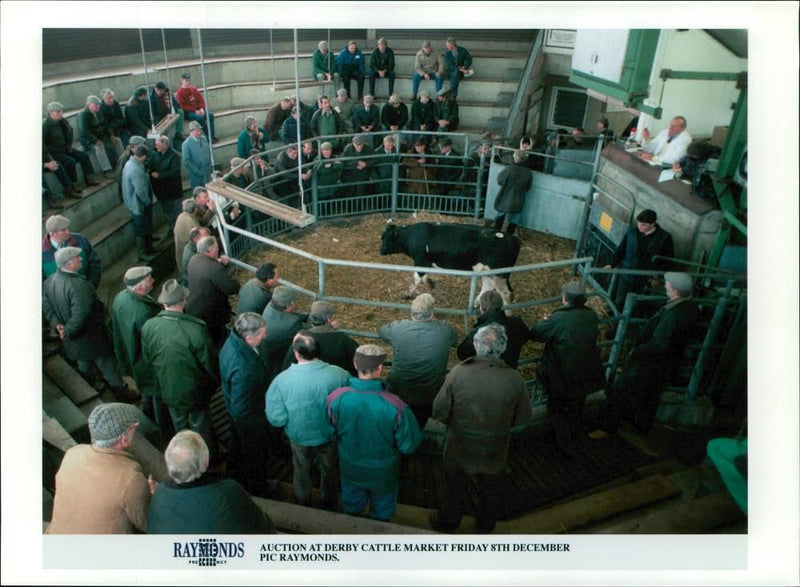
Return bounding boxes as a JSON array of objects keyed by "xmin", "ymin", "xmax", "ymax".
[{"xmin": 381, "ymin": 222, "xmax": 520, "ymax": 304}]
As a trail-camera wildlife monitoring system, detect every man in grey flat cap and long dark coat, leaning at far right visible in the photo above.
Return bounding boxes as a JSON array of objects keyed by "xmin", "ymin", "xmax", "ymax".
[{"xmin": 589, "ymin": 272, "xmax": 698, "ymax": 439}]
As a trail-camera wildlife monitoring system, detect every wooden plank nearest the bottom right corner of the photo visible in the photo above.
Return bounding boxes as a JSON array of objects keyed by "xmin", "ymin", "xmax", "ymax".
[{"xmin": 598, "ymin": 493, "xmax": 745, "ymax": 534}]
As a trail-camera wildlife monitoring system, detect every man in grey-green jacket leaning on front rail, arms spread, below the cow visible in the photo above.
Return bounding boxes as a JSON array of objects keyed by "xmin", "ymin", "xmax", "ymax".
[{"xmin": 378, "ymin": 293, "xmax": 458, "ymax": 428}]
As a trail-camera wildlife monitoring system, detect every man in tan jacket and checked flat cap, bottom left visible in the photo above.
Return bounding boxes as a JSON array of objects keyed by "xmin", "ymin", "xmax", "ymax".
[{"xmin": 47, "ymin": 403, "xmax": 156, "ymax": 534}]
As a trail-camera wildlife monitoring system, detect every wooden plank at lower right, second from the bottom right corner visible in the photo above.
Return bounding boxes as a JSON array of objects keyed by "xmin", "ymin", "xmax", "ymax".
[{"xmin": 509, "ymin": 475, "xmax": 681, "ymax": 534}]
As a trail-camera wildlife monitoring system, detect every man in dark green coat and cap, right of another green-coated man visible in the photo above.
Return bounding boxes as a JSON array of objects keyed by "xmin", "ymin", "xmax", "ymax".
[{"xmin": 142, "ymin": 279, "xmax": 219, "ymax": 452}]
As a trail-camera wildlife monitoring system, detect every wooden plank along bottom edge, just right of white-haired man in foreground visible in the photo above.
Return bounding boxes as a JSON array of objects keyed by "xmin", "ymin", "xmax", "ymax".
[{"xmin": 253, "ymin": 497, "xmax": 434, "ymax": 534}]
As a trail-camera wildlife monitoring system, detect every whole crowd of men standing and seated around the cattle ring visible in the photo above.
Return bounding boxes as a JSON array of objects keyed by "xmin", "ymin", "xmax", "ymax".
[{"xmin": 42, "ymin": 39, "xmax": 697, "ymax": 533}]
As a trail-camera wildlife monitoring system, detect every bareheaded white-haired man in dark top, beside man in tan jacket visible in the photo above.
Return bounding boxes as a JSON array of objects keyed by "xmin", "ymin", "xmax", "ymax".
[{"xmin": 147, "ymin": 430, "xmax": 275, "ymax": 535}]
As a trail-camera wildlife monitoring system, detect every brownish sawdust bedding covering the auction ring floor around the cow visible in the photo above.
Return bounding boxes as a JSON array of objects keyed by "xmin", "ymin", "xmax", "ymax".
[{"xmin": 232, "ymin": 212, "xmax": 605, "ymax": 379}]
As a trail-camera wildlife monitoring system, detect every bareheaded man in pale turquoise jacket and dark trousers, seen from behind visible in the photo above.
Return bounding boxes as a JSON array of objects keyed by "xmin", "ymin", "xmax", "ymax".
[{"xmin": 266, "ymin": 330, "xmax": 350, "ymax": 509}]
